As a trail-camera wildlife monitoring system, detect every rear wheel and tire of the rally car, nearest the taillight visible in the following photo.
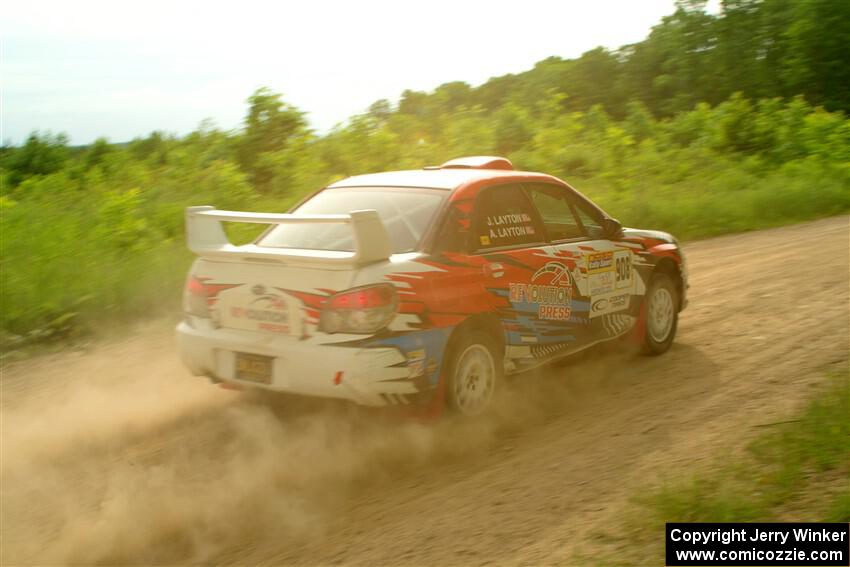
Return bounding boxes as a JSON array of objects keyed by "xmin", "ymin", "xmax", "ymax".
[{"xmin": 446, "ymin": 331, "xmax": 496, "ymax": 417}]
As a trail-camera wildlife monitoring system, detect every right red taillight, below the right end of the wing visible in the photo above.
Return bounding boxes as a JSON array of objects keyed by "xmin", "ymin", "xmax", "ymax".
[{"xmin": 319, "ymin": 284, "xmax": 398, "ymax": 334}]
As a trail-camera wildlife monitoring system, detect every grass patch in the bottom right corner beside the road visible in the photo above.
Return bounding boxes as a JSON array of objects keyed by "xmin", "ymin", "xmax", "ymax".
[{"xmin": 579, "ymin": 370, "xmax": 850, "ymax": 565}]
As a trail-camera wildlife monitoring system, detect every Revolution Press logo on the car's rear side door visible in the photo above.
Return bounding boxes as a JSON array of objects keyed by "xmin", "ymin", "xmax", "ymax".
[{"xmin": 509, "ymin": 262, "xmax": 573, "ymax": 321}]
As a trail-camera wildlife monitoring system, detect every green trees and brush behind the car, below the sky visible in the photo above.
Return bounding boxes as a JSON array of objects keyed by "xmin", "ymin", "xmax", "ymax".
[{"xmin": 0, "ymin": 0, "xmax": 850, "ymax": 346}]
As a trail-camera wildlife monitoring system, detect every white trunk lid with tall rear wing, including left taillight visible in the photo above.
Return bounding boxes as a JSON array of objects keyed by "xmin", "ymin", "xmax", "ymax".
[{"xmin": 186, "ymin": 207, "xmax": 392, "ymax": 337}]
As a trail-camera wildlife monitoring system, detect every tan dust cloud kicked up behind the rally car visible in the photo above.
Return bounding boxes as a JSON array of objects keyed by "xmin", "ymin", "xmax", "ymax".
[{"xmin": 2, "ymin": 330, "xmax": 608, "ymax": 564}]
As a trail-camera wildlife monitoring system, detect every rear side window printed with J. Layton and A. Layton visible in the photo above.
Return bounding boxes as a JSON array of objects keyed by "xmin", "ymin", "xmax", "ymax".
[{"xmin": 473, "ymin": 185, "xmax": 546, "ymax": 249}]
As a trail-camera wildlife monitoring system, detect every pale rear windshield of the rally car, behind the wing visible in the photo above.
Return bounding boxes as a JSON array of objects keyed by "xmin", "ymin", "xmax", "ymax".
[{"xmin": 258, "ymin": 187, "xmax": 448, "ymax": 254}]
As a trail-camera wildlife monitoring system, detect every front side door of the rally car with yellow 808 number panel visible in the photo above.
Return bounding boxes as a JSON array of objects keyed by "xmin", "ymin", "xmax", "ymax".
[{"xmin": 524, "ymin": 183, "xmax": 638, "ymax": 343}]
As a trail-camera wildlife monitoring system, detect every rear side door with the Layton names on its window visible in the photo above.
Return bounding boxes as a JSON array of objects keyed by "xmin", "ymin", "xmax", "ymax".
[{"xmin": 470, "ymin": 184, "xmax": 586, "ymax": 366}]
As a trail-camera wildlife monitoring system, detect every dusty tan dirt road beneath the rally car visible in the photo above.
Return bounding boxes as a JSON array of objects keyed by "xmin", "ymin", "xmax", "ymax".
[{"xmin": 0, "ymin": 217, "xmax": 850, "ymax": 565}]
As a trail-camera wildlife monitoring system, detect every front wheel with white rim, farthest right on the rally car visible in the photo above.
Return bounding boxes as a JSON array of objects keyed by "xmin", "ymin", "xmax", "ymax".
[{"xmin": 641, "ymin": 273, "xmax": 680, "ymax": 356}]
